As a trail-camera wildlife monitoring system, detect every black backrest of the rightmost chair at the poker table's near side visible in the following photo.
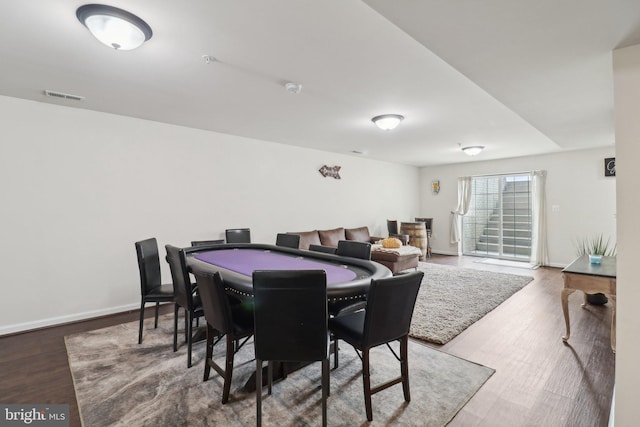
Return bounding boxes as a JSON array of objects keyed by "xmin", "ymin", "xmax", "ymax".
[{"xmin": 363, "ymin": 271, "xmax": 424, "ymax": 347}]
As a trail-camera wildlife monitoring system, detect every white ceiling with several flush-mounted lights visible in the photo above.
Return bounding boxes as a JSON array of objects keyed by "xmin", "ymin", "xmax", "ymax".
[{"xmin": 0, "ymin": 0, "xmax": 640, "ymax": 166}]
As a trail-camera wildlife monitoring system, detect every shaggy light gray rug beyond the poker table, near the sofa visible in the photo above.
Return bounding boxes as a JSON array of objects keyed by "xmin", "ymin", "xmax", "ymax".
[{"xmin": 410, "ymin": 262, "xmax": 533, "ymax": 344}]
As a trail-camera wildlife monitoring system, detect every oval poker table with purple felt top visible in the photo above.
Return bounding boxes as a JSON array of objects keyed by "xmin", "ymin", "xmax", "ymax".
[{"xmin": 184, "ymin": 243, "xmax": 391, "ymax": 302}]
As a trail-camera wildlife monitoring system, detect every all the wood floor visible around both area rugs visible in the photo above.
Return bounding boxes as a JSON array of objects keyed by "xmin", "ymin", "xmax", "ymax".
[{"xmin": 0, "ymin": 255, "xmax": 615, "ymax": 427}]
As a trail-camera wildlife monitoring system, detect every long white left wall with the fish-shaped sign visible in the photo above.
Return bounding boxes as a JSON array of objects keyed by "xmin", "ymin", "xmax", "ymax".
[{"xmin": 0, "ymin": 97, "xmax": 419, "ymax": 334}]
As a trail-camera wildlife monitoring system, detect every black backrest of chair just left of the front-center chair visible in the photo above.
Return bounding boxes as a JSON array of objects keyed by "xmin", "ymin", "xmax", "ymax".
[{"xmin": 194, "ymin": 270, "xmax": 233, "ymax": 334}]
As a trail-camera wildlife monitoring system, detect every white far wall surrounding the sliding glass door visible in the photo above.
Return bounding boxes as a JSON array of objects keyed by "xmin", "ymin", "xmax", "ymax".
[{"xmin": 420, "ymin": 145, "xmax": 616, "ymax": 266}]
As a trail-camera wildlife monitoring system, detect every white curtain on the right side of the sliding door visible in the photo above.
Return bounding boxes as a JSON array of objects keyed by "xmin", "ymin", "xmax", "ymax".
[{"xmin": 530, "ymin": 171, "xmax": 549, "ymax": 265}]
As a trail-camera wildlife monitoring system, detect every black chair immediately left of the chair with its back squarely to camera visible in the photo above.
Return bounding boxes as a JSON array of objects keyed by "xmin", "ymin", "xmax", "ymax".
[{"xmin": 193, "ymin": 268, "xmax": 253, "ymax": 404}]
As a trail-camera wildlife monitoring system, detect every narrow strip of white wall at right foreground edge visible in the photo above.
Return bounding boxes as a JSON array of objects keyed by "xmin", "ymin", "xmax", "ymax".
[{"xmin": 613, "ymin": 45, "xmax": 640, "ymax": 426}]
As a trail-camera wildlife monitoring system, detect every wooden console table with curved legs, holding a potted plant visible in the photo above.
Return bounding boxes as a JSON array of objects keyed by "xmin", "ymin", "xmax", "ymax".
[{"xmin": 562, "ymin": 255, "xmax": 616, "ymax": 352}]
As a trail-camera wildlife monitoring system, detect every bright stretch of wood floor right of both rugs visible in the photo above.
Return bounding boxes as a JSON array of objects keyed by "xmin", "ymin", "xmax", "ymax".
[{"xmin": 433, "ymin": 257, "xmax": 615, "ymax": 427}]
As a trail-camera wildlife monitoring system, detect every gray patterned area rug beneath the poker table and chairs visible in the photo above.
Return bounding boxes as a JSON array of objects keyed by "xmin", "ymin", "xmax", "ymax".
[{"xmin": 65, "ymin": 315, "xmax": 494, "ymax": 427}]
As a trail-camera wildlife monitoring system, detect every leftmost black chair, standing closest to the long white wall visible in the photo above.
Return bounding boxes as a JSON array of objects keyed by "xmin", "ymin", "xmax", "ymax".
[{"xmin": 135, "ymin": 237, "xmax": 174, "ymax": 344}]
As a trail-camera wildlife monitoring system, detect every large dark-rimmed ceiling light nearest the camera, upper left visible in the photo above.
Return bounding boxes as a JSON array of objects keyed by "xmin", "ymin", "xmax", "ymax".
[{"xmin": 76, "ymin": 4, "xmax": 153, "ymax": 50}]
